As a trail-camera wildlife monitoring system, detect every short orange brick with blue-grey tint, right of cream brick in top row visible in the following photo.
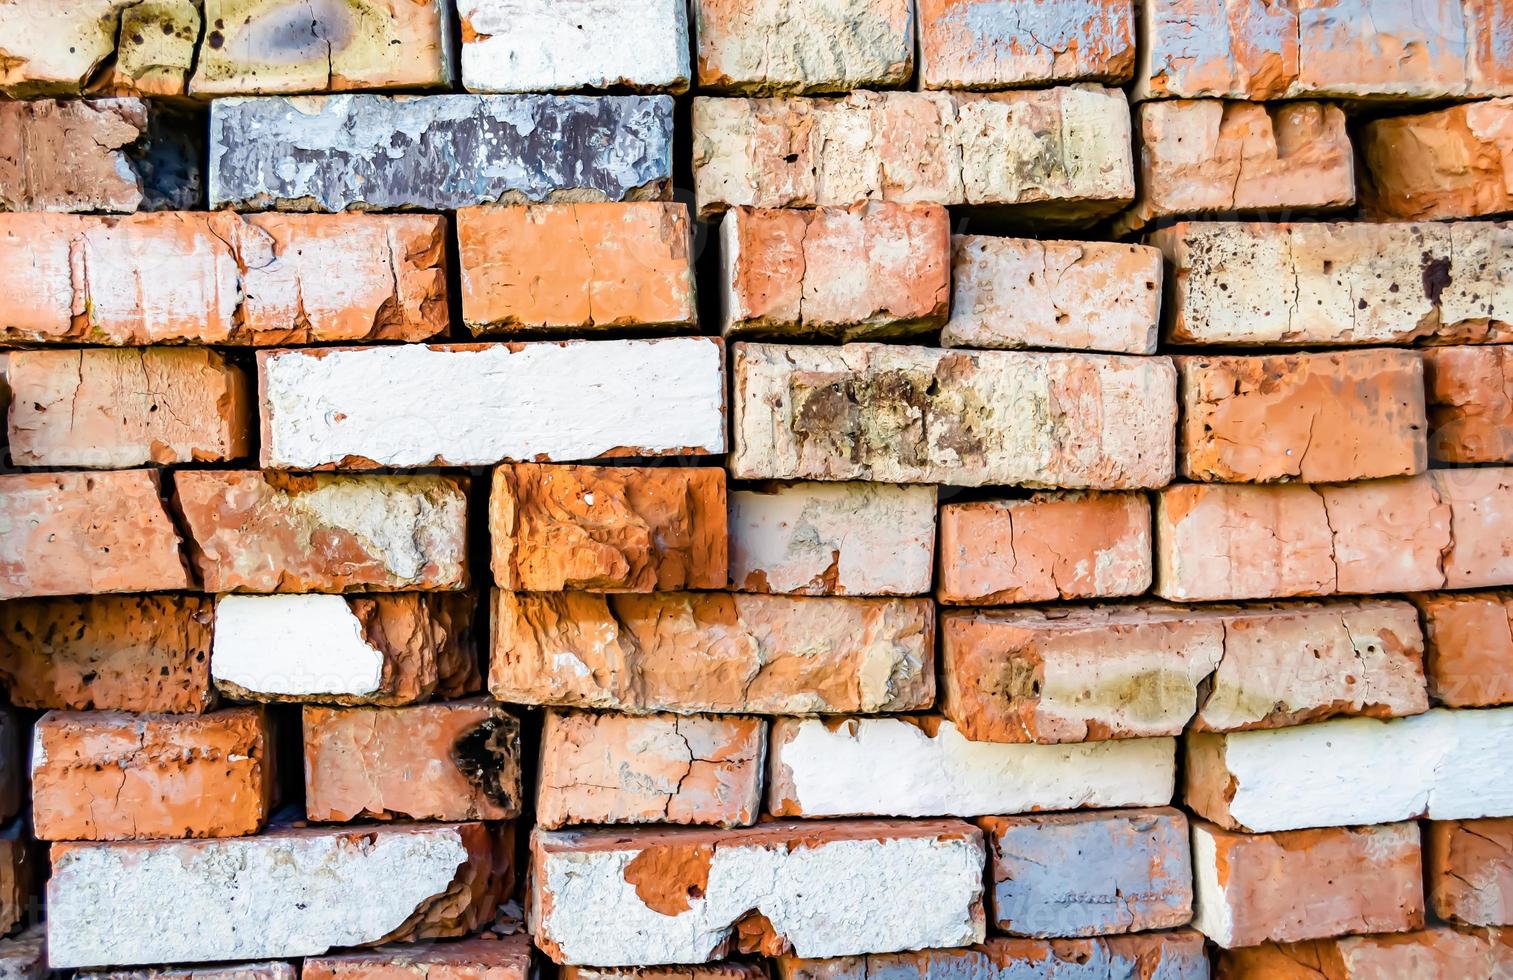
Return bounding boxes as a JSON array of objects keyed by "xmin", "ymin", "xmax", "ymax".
[{"xmin": 918, "ymin": 0, "xmax": 1136, "ymax": 89}]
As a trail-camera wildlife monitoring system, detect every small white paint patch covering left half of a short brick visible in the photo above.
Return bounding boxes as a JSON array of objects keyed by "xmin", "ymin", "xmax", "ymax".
[{"xmin": 210, "ymin": 596, "xmax": 384, "ymax": 697}]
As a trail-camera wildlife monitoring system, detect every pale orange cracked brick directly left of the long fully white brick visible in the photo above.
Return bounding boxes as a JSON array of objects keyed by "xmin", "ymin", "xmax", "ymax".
[{"xmin": 6, "ymin": 348, "xmax": 256, "ymax": 469}]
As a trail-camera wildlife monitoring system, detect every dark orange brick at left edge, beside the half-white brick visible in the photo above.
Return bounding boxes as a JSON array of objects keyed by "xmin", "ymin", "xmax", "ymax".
[{"xmin": 0, "ymin": 594, "xmax": 216, "ymax": 714}]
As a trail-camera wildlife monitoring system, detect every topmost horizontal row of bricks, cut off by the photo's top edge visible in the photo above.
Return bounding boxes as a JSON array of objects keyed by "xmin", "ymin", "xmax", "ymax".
[{"xmin": 11, "ymin": 0, "xmax": 1513, "ymax": 98}]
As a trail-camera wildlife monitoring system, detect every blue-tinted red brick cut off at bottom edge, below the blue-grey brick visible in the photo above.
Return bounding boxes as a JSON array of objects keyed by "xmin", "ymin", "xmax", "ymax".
[{"xmin": 776, "ymin": 929, "xmax": 1209, "ymax": 980}]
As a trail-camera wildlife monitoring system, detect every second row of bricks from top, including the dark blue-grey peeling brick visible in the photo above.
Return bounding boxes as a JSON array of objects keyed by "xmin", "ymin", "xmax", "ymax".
[{"xmin": 11, "ymin": 85, "xmax": 1513, "ymax": 223}]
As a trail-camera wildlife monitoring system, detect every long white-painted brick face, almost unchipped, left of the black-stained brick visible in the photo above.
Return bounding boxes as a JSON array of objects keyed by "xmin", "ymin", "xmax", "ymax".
[{"xmin": 259, "ymin": 337, "xmax": 725, "ymax": 469}]
